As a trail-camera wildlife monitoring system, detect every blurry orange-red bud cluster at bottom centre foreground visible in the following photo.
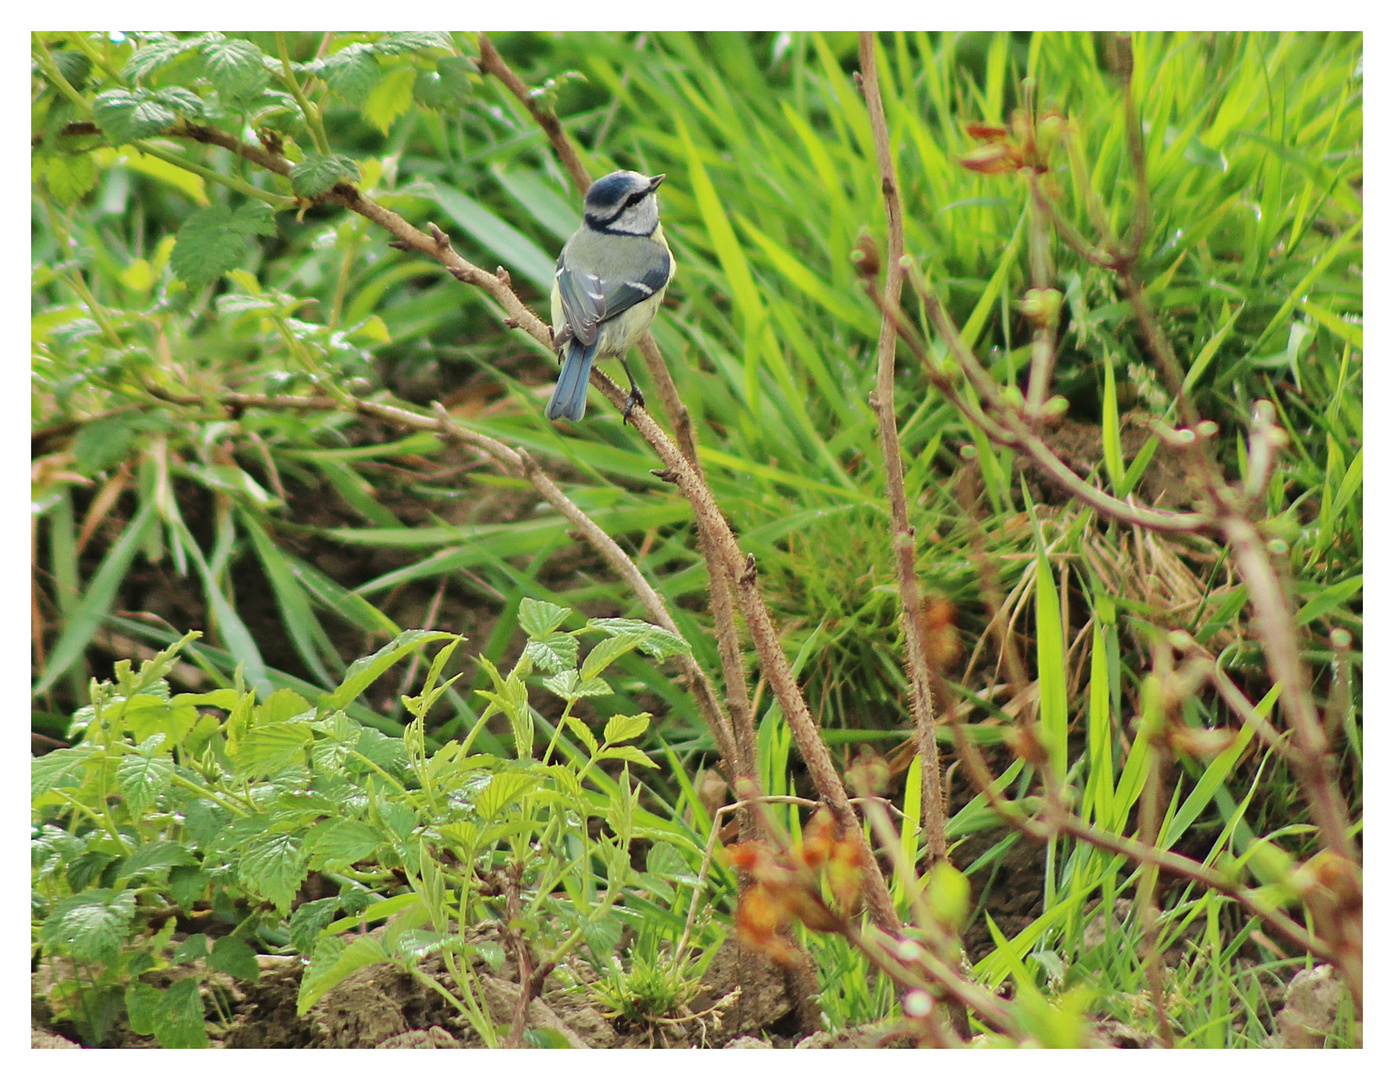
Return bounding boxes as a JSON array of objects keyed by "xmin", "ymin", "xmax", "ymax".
[{"xmin": 725, "ymin": 807, "xmax": 866, "ymax": 963}]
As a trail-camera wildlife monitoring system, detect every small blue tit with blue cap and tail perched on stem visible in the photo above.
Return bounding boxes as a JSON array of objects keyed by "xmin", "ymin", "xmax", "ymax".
[{"xmin": 546, "ymin": 170, "xmax": 675, "ymax": 419}]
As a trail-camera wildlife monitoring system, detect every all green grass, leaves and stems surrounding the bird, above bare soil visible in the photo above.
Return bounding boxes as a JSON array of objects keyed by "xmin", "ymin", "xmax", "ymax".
[{"xmin": 32, "ymin": 32, "xmax": 1363, "ymax": 1047}]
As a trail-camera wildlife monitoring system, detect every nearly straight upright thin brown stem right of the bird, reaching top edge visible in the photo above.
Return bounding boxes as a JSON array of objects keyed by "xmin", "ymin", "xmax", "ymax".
[{"xmin": 859, "ymin": 31, "xmax": 948, "ymax": 861}]
